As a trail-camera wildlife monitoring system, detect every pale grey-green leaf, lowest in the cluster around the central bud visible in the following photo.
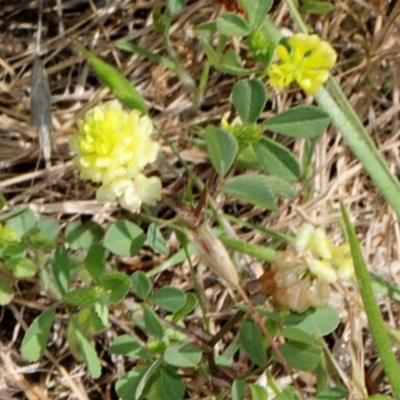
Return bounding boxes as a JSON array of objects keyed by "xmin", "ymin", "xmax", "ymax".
[{"xmin": 221, "ymin": 174, "xmax": 275, "ymax": 210}]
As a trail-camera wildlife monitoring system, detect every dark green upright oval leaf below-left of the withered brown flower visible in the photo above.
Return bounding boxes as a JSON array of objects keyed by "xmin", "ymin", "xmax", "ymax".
[{"xmin": 239, "ymin": 320, "xmax": 268, "ymax": 367}]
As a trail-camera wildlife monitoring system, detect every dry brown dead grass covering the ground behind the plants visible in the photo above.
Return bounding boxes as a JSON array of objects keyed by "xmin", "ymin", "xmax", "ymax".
[{"xmin": 0, "ymin": 0, "xmax": 400, "ymax": 400}]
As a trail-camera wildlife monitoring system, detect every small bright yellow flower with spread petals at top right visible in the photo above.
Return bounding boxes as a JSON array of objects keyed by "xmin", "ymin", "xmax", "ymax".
[{"xmin": 268, "ymin": 33, "xmax": 337, "ymax": 95}]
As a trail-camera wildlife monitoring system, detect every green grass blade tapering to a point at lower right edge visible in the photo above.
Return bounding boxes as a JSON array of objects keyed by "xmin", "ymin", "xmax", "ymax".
[{"xmin": 341, "ymin": 204, "xmax": 400, "ymax": 400}]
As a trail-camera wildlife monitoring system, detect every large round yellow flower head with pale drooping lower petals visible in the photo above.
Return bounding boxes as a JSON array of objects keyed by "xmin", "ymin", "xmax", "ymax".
[{"xmin": 69, "ymin": 100, "xmax": 161, "ymax": 212}]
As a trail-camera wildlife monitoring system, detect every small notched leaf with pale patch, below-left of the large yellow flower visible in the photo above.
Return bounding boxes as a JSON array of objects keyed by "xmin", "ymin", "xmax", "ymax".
[{"xmin": 65, "ymin": 221, "xmax": 104, "ymax": 250}]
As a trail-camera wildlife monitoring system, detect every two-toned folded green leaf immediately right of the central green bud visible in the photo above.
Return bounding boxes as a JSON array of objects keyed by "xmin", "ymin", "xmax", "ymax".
[{"xmin": 253, "ymin": 137, "xmax": 301, "ymax": 181}]
